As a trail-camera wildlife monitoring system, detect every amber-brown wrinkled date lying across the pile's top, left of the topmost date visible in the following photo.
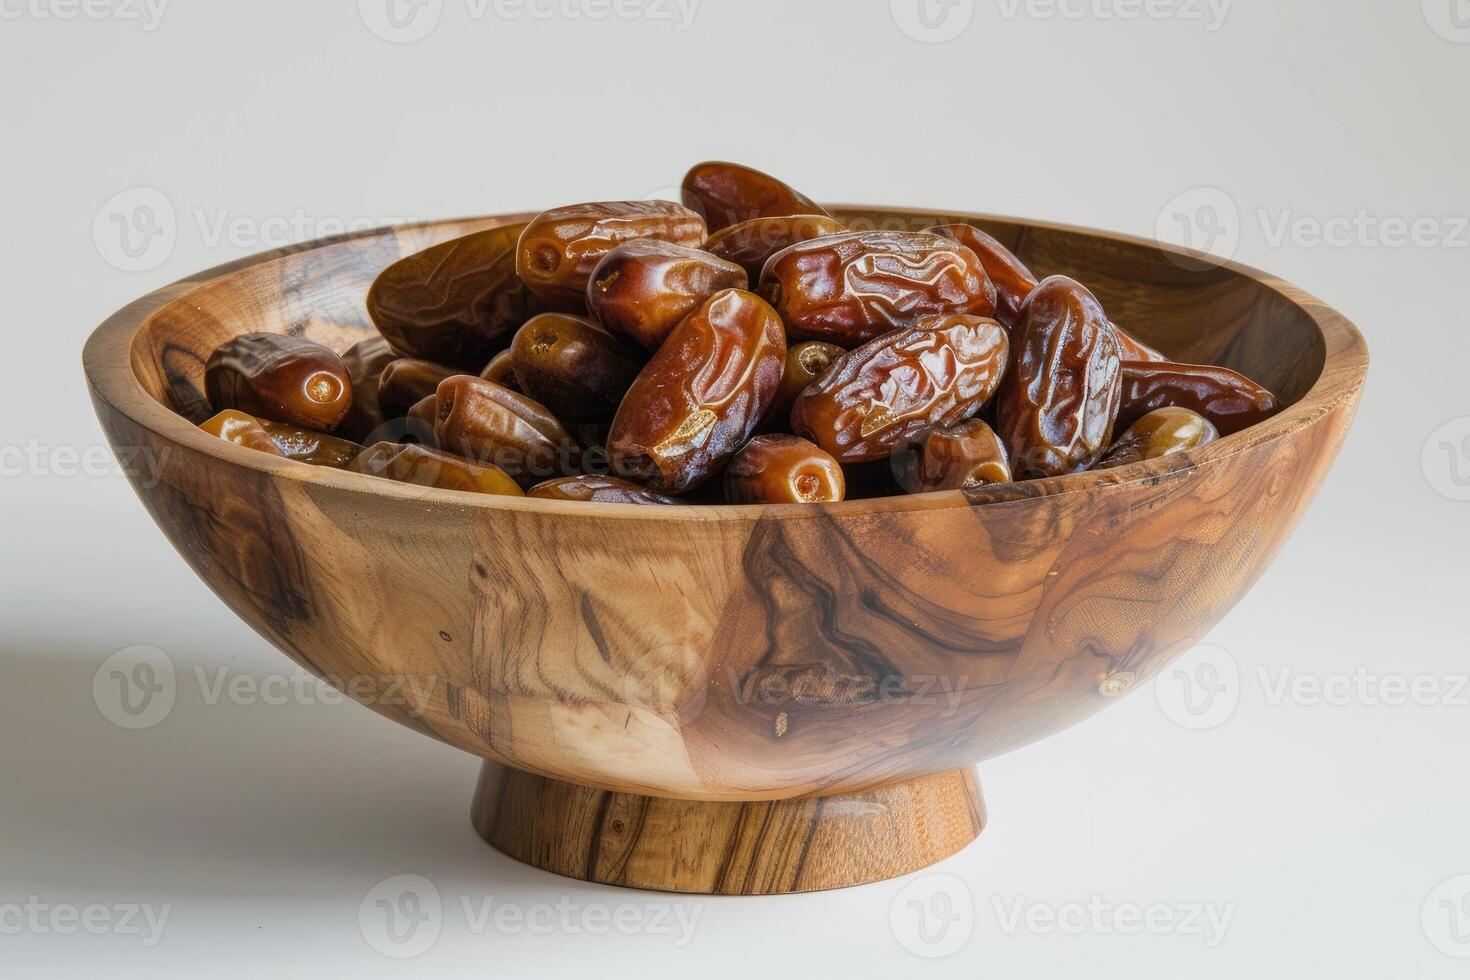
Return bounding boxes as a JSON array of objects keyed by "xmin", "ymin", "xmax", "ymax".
[{"xmin": 516, "ymin": 201, "xmax": 707, "ymax": 304}]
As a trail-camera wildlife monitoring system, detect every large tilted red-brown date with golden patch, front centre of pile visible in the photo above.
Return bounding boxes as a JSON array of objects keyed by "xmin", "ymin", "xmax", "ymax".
[{"xmin": 607, "ymin": 289, "xmax": 786, "ymax": 494}]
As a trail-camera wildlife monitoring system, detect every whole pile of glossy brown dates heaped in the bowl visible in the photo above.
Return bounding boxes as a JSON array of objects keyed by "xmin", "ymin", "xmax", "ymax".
[{"xmin": 203, "ymin": 163, "xmax": 1279, "ymax": 504}]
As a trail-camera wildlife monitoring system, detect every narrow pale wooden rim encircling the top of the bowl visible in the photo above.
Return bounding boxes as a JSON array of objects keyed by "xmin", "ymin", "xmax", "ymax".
[{"xmin": 82, "ymin": 204, "xmax": 1369, "ymax": 522}]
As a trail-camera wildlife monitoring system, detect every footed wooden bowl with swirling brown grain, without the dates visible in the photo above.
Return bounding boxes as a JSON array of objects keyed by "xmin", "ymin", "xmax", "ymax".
[{"xmin": 84, "ymin": 207, "xmax": 1367, "ymax": 893}]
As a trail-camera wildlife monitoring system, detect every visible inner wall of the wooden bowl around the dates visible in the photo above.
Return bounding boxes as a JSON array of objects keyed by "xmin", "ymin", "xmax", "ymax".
[{"xmin": 131, "ymin": 207, "xmax": 1326, "ymax": 422}]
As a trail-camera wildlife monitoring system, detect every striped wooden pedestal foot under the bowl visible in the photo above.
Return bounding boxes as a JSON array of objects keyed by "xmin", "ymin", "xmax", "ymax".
[{"xmin": 472, "ymin": 761, "xmax": 985, "ymax": 895}]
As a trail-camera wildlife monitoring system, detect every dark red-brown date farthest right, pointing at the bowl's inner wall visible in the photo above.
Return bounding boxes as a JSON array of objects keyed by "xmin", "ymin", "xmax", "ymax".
[{"xmin": 1119, "ymin": 361, "xmax": 1282, "ymax": 435}]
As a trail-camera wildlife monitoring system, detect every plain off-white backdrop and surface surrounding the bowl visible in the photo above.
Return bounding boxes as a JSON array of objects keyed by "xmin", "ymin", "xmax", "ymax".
[{"xmin": 0, "ymin": 0, "xmax": 1470, "ymax": 980}]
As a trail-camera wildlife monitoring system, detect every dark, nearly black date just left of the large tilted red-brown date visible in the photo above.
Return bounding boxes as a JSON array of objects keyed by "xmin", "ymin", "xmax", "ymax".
[{"xmin": 510, "ymin": 313, "xmax": 642, "ymax": 422}]
